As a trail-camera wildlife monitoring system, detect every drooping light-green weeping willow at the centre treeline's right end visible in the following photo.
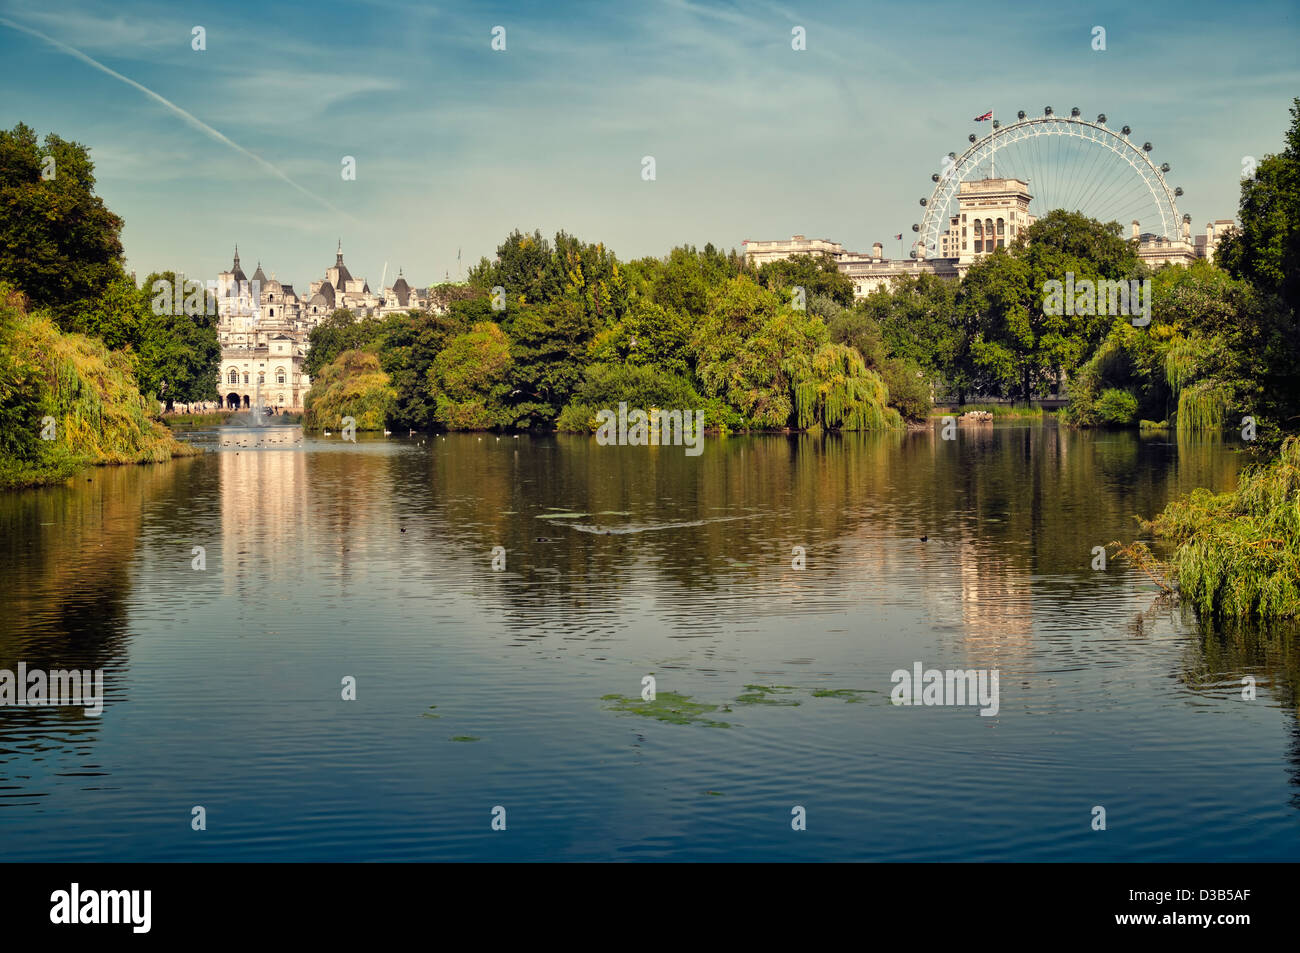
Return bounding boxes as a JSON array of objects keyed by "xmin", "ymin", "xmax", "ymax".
[{"xmin": 787, "ymin": 345, "xmax": 902, "ymax": 430}]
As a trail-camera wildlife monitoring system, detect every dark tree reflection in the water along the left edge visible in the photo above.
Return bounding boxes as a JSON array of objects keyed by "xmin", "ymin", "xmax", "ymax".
[{"xmin": 0, "ymin": 460, "xmax": 192, "ymax": 793}]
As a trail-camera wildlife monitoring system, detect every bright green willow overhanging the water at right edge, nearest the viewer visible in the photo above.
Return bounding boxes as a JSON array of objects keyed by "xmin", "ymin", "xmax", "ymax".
[{"xmin": 1144, "ymin": 437, "xmax": 1300, "ymax": 620}]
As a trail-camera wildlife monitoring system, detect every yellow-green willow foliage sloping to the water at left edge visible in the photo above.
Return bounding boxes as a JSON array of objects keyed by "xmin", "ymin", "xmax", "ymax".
[{"xmin": 0, "ymin": 294, "xmax": 200, "ymax": 489}]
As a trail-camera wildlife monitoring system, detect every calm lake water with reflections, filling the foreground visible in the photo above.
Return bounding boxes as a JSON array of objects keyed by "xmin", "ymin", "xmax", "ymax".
[{"xmin": 0, "ymin": 423, "xmax": 1300, "ymax": 861}]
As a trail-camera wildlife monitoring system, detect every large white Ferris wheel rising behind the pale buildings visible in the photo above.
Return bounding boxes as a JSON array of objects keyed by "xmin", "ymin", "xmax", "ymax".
[{"xmin": 911, "ymin": 107, "xmax": 1191, "ymax": 257}]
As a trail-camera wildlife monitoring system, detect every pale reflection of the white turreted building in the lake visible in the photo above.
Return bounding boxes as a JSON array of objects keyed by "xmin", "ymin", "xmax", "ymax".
[{"xmin": 220, "ymin": 442, "xmax": 311, "ymax": 592}]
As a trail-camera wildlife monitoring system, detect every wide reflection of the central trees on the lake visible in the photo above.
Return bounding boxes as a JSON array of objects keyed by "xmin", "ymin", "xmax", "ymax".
[{"xmin": 397, "ymin": 423, "xmax": 1238, "ymax": 647}]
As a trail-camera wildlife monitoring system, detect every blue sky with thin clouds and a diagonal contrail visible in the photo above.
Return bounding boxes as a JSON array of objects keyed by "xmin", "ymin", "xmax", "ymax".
[{"xmin": 0, "ymin": 0, "xmax": 1300, "ymax": 290}]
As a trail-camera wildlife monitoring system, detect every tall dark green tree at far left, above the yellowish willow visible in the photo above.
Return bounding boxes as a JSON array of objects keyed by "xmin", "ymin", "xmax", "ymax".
[{"xmin": 0, "ymin": 122, "xmax": 122, "ymax": 321}]
